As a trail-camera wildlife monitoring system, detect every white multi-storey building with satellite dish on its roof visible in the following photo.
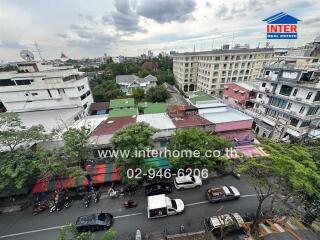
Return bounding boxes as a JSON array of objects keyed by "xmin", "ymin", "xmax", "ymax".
[{"xmin": 0, "ymin": 62, "xmax": 93, "ymax": 112}]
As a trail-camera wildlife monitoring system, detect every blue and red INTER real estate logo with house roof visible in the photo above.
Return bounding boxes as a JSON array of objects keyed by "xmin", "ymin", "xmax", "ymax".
[{"xmin": 263, "ymin": 12, "xmax": 301, "ymax": 39}]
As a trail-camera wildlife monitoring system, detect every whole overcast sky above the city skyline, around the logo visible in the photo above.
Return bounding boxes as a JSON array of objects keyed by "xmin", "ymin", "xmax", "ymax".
[{"xmin": 0, "ymin": 0, "xmax": 320, "ymax": 61}]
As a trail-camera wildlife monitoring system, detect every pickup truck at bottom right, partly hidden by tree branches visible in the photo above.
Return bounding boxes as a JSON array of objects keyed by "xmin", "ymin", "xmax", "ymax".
[{"xmin": 205, "ymin": 213, "xmax": 244, "ymax": 234}]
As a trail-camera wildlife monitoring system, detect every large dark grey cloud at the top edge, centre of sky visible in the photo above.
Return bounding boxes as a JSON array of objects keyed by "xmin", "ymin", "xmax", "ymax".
[{"xmin": 137, "ymin": 0, "xmax": 196, "ymax": 23}]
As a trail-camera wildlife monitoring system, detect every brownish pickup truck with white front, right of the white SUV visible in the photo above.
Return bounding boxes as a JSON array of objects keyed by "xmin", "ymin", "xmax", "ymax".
[{"xmin": 206, "ymin": 186, "xmax": 240, "ymax": 203}]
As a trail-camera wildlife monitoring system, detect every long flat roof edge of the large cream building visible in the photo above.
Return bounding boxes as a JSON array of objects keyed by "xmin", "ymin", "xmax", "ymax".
[{"xmin": 173, "ymin": 48, "xmax": 274, "ymax": 57}]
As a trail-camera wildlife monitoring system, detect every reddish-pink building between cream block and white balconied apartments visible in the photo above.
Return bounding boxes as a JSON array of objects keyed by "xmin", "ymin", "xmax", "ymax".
[{"xmin": 223, "ymin": 83, "xmax": 255, "ymax": 109}]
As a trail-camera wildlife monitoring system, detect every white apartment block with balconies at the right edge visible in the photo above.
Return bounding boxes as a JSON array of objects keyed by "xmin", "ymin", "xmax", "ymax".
[{"xmin": 247, "ymin": 64, "xmax": 320, "ymax": 140}]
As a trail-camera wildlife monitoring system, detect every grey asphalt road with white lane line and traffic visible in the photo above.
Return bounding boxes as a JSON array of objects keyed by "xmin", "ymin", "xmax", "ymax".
[{"xmin": 0, "ymin": 176, "xmax": 266, "ymax": 240}]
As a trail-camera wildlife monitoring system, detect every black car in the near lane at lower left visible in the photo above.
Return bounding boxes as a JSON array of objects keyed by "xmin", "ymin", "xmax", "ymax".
[{"xmin": 76, "ymin": 213, "xmax": 113, "ymax": 232}]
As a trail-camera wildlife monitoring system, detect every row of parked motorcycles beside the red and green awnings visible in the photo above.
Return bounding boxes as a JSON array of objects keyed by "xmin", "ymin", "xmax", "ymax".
[{"xmin": 32, "ymin": 190, "xmax": 101, "ymax": 215}]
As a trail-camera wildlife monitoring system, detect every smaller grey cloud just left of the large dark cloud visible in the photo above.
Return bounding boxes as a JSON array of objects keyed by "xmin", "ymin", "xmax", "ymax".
[{"xmin": 102, "ymin": 0, "xmax": 146, "ymax": 33}]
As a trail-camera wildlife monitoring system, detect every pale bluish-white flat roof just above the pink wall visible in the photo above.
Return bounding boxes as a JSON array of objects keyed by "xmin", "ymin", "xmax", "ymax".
[{"xmin": 200, "ymin": 107, "xmax": 253, "ymax": 123}]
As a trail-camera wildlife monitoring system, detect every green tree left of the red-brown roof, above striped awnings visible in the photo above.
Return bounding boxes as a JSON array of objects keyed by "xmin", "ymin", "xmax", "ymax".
[{"xmin": 63, "ymin": 126, "xmax": 91, "ymax": 170}]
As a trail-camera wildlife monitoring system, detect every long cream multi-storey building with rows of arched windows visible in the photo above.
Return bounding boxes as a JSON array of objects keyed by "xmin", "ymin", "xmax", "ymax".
[{"xmin": 173, "ymin": 48, "xmax": 274, "ymax": 95}]
